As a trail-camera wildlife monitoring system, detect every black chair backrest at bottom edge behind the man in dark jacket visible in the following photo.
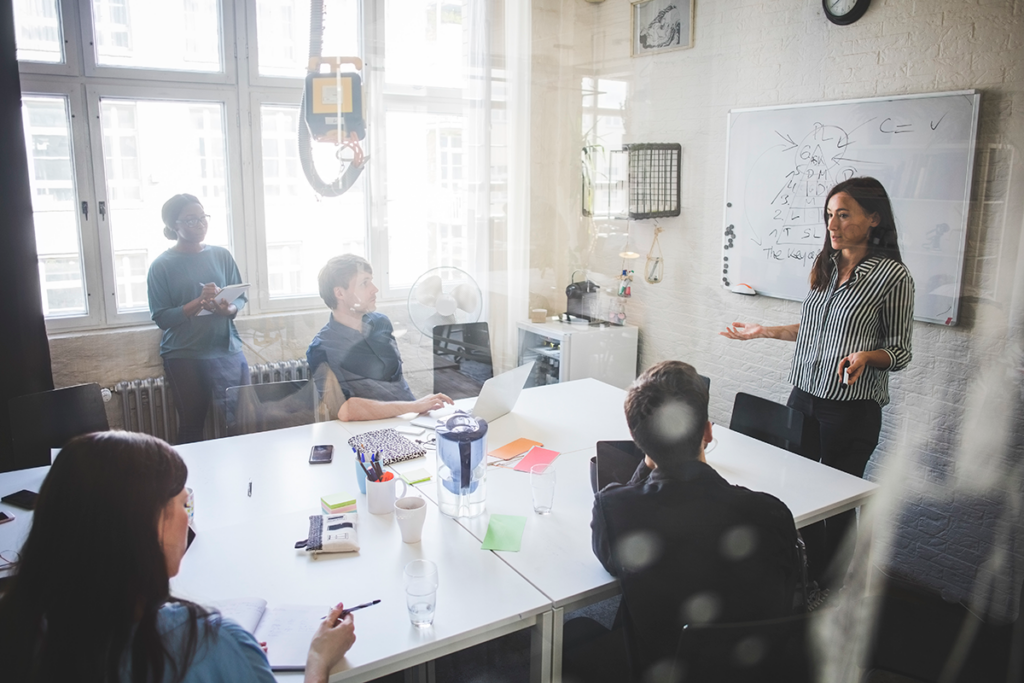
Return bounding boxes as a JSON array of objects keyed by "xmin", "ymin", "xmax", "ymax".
[{"xmin": 667, "ymin": 614, "xmax": 812, "ymax": 683}]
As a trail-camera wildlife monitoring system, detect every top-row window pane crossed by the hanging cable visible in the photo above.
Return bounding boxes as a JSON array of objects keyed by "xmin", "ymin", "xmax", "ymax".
[{"xmin": 256, "ymin": 0, "xmax": 360, "ymax": 78}]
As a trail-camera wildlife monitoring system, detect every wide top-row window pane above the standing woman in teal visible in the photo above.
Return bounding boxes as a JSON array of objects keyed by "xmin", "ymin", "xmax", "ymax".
[{"xmin": 92, "ymin": 0, "xmax": 224, "ymax": 72}]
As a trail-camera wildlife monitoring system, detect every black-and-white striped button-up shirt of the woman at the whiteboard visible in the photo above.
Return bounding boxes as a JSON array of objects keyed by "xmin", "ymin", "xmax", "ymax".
[{"xmin": 790, "ymin": 252, "xmax": 913, "ymax": 405}]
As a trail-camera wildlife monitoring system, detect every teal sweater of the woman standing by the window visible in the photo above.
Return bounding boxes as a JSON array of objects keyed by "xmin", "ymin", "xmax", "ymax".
[{"xmin": 146, "ymin": 246, "xmax": 246, "ymax": 358}]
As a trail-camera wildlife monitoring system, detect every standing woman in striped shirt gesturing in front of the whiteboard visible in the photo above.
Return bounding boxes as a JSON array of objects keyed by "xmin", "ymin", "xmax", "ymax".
[{"xmin": 720, "ymin": 178, "xmax": 913, "ymax": 587}]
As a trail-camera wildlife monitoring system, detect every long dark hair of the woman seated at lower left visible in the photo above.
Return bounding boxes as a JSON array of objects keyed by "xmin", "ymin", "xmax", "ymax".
[{"xmin": 0, "ymin": 432, "xmax": 208, "ymax": 683}]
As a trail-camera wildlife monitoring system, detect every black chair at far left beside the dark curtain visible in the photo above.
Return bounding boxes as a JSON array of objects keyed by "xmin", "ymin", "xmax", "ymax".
[{"xmin": 7, "ymin": 383, "xmax": 110, "ymax": 470}]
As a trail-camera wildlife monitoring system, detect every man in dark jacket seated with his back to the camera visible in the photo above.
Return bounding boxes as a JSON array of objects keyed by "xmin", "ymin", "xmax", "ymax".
[{"xmin": 591, "ymin": 360, "xmax": 800, "ymax": 669}]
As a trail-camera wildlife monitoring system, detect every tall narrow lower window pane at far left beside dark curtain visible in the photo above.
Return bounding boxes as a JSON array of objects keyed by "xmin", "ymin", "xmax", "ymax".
[{"xmin": 22, "ymin": 95, "xmax": 88, "ymax": 316}]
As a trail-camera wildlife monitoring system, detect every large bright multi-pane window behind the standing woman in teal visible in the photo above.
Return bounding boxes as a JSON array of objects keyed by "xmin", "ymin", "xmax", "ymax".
[{"xmin": 15, "ymin": 0, "xmax": 495, "ymax": 331}]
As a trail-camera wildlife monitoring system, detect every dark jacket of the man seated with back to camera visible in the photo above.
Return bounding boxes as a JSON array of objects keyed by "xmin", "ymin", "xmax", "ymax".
[{"xmin": 591, "ymin": 461, "xmax": 799, "ymax": 668}]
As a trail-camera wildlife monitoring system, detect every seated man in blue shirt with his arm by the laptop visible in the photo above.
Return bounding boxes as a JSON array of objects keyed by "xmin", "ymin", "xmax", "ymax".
[{"xmin": 306, "ymin": 254, "xmax": 452, "ymax": 422}]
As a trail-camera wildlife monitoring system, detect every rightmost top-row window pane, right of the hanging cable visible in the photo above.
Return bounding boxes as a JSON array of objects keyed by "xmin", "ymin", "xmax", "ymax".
[{"xmin": 384, "ymin": 0, "xmax": 469, "ymax": 88}]
